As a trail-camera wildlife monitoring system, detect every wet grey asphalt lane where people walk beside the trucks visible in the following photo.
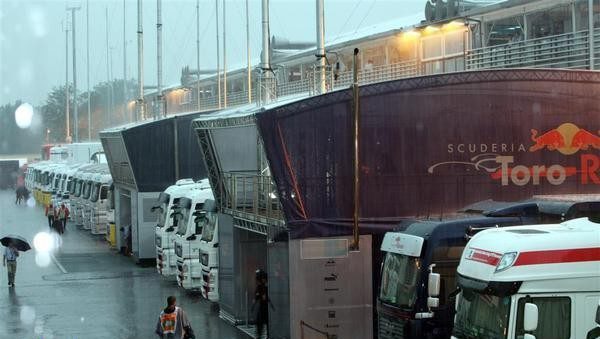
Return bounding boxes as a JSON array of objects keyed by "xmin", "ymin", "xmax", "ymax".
[{"xmin": 0, "ymin": 191, "xmax": 249, "ymax": 339}]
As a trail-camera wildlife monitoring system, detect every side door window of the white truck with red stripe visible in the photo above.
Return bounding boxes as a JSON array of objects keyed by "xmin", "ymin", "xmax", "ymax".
[{"xmin": 516, "ymin": 297, "xmax": 571, "ymax": 339}]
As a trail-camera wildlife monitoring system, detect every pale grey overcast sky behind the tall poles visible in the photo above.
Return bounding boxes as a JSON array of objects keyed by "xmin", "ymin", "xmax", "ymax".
[{"xmin": 0, "ymin": 0, "xmax": 425, "ymax": 105}]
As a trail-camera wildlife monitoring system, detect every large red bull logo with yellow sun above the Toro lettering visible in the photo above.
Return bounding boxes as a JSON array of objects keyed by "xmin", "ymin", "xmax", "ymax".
[{"xmin": 529, "ymin": 123, "xmax": 600, "ymax": 155}]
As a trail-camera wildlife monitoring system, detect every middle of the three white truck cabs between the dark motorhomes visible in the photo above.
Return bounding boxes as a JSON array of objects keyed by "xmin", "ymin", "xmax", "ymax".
[{"xmin": 174, "ymin": 180, "xmax": 214, "ymax": 291}]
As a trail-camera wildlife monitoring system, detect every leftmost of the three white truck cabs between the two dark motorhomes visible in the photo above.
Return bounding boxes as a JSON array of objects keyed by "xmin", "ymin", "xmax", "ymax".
[{"xmin": 152, "ymin": 179, "xmax": 199, "ymax": 276}]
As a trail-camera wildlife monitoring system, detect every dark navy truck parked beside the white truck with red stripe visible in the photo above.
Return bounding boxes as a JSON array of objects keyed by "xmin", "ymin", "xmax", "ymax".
[{"xmin": 377, "ymin": 196, "xmax": 600, "ymax": 339}]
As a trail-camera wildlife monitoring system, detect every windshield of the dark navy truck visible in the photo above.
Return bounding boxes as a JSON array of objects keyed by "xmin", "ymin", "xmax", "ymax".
[{"xmin": 379, "ymin": 252, "xmax": 421, "ymax": 308}]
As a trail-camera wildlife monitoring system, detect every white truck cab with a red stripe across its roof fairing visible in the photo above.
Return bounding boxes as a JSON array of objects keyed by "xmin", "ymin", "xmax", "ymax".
[{"xmin": 452, "ymin": 218, "xmax": 600, "ymax": 339}]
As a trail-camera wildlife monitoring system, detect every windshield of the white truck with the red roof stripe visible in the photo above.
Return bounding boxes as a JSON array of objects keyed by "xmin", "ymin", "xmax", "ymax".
[{"xmin": 452, "ymin": 289, "xmax": 510, "ymax": 339}]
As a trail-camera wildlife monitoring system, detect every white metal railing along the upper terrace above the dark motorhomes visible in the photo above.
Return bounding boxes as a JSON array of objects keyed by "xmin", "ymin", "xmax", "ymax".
[{"xmin": 171, "ymin": 29, "xmax": 600, "ymax": 112}]
